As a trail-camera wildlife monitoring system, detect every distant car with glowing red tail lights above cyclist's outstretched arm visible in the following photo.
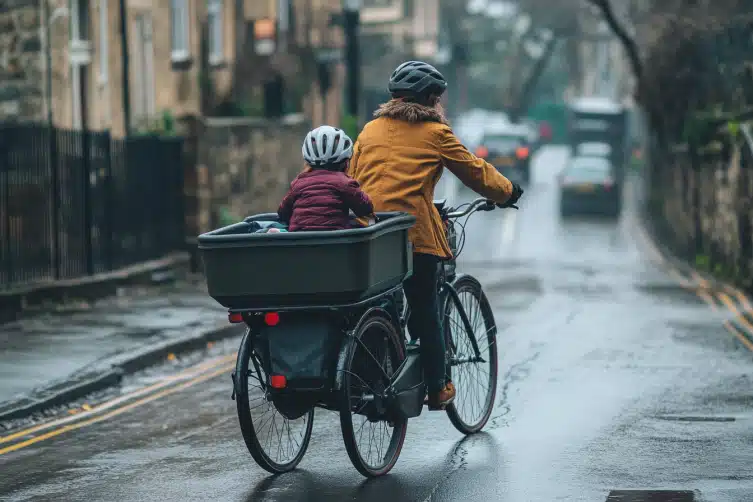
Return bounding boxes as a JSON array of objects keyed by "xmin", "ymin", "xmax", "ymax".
[{"xmin": 476, "ymin": 123, "xmax": 532, "ymax": 183}]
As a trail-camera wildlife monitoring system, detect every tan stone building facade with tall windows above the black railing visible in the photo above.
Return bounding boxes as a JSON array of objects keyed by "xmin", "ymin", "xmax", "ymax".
[{"xmin": 0, "ymin": 0, "xmax": 236, "ymax": 136}]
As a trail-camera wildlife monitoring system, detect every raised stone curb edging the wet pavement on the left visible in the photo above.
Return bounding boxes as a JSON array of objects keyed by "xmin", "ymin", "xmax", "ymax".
[{"xmin": 0, "ymin": 324, "xmax": 243, "ymax": 422}]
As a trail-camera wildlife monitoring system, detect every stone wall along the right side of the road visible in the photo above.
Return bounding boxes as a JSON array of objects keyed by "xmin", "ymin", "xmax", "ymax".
[{"xmin": 647, "ymin": 135, "xmax": 753, "ymax": 292}]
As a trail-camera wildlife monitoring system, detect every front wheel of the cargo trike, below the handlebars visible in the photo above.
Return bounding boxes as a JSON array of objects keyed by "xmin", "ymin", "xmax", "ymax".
[{"xmin": 444, "ymin": 275, "xmax": 498, "ymax": 434}]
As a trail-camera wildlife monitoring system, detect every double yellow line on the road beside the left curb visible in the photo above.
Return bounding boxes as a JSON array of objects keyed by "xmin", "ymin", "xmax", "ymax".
[{"xmin": 0, "ymin": 354, "xmax": 235, "ymax": 455}]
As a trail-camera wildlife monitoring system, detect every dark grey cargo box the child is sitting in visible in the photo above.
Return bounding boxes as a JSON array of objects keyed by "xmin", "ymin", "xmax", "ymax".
[{"xmin": 198, "ymin": 213, "xmax": 416, "ymax": 310}]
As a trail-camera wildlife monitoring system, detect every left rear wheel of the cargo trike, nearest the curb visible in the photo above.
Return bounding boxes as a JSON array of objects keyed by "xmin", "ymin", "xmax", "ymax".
[{"xmin": 235, "ymin": 330, "xmax": 314, "ymax": 474}]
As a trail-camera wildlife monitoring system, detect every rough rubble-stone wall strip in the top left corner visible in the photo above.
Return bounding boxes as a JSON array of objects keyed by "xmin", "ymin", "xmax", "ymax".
[{"xmin": 0, "ymin": 0, "xmax": 45, "ymax": 121}]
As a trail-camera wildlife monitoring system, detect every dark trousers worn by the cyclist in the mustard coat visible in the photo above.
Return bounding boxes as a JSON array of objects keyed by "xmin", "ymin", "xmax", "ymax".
[{"xmin": 403, "ymin": 253, "xmax": 447, "ymax": 393}]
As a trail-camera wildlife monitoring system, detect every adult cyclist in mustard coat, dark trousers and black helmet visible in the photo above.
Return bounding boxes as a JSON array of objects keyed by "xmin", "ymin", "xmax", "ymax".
[{"xmin": 348, "ymin": 61, "xmax": 523, "ymax": 410}]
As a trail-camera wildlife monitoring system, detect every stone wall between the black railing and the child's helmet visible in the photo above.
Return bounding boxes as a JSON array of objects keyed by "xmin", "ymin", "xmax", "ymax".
[{"xmin": 197, "ymin": 116, "xmax": 310, "ymax": 232}]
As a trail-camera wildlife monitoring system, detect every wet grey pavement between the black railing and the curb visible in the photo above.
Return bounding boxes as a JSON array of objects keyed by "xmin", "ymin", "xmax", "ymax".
[{"xmin": 0, "ymin": 280, "xmax": 237, "ymax": 421}]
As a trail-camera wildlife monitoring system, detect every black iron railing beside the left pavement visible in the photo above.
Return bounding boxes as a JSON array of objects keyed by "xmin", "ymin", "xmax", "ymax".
[{"xmin": 0, "ymin": 124, "xmax": 185, "ymax": 290}]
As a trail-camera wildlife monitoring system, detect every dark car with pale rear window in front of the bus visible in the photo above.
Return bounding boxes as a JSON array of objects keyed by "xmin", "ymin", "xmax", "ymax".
[{"xmin": 559, "ymin": 156, "xmax": 622, "ymax": 218}]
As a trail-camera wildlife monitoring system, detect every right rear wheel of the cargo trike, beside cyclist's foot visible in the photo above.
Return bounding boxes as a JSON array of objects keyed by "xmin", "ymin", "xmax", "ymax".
[{"xmin": 338, "ymin": 310, "xmax": 408, "ymax": 477}]
